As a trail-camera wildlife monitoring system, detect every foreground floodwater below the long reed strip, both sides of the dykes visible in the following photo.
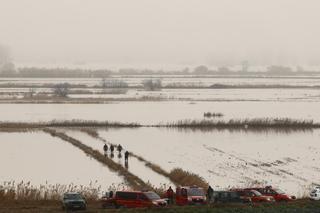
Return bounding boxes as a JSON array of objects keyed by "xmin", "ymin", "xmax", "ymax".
[{"xmin": 0, "ymin": 127, "xmax": 320, "ymax": 197}]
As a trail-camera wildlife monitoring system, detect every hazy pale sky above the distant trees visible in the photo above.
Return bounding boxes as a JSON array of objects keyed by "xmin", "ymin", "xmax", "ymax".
[{"xmin": 0, "ymin": 0, "xmax": 320, "ymax": 67}]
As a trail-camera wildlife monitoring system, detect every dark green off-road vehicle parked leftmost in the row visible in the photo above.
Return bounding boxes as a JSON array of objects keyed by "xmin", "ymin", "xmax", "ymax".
[{"xmin": 62, "ymin": 192, "xmax": 87, "ymax": 210}]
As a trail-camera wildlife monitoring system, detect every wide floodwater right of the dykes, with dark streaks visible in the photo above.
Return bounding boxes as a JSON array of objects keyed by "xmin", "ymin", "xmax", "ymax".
[{"xmin": 99, "ymin": 128, "xmax": 320, "ymax": 196}]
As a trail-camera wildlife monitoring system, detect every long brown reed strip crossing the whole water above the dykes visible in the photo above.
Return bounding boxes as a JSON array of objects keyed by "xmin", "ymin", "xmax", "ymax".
[{"xmin": 0, "ymin": 118, "xmax": 320, "ymax": 131}]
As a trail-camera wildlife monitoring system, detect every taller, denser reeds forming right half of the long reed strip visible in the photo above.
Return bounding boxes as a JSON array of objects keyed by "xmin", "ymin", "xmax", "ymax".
[{"xmin": 160, "ymin": 118, "xmax": 320, "ymax": 129}]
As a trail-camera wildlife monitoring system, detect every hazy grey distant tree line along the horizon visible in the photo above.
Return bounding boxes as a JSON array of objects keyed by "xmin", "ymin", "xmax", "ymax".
[{"xmin": 0, "ymin": 65, "xmax": 319, "ymax": 78}]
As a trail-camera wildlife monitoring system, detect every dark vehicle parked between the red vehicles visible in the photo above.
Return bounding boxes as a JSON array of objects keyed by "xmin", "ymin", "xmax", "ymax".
[{"xmin": 213, "ymin": 191, "xmax": 251, "ymax": 203}]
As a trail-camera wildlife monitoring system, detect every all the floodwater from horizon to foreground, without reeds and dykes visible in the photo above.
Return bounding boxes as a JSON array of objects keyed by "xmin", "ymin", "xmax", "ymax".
[{"xmin": 0, "ymin": 76, "xmax": 320, "ymax": 197}]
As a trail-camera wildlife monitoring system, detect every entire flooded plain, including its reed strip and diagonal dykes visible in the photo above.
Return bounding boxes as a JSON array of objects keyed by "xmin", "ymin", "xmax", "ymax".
[{"xmin": 0, "ymin": 77, "xmax": 320, "ymax": 203}]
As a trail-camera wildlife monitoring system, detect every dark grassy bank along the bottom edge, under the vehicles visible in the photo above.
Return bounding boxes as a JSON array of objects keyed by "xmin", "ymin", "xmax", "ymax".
[{"xmin": 0, "ymin": 200, "xmax": 320, "ymax": 213}]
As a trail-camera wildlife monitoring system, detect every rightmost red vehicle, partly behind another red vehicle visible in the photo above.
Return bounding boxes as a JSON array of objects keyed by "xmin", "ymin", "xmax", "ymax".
[{"xmin": 246, "ymin": 186, "xmax": 296, "ymax": 202}]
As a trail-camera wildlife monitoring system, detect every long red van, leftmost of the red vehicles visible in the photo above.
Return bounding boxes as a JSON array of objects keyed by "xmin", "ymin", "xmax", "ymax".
[{"xmin": 102, "ymin": 191, "xmax": 167, "ymax": 208}]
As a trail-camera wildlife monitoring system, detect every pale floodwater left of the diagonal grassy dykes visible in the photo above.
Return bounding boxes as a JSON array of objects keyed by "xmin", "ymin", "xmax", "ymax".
[{"xmin": 0, "ymin": 132, "xmax": 123, "ymax": 189}]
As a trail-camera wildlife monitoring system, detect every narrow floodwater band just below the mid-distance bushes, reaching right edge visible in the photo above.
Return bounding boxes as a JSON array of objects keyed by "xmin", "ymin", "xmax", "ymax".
[{"xmin": 69, "ymin": 89, "xmax": 320, "ymax": 102}]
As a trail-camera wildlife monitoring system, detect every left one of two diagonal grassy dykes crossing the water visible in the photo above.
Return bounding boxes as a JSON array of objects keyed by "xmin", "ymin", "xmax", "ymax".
[{"xmin": 43, "ymin": 129, "xmax": 152, "ymax": 190}]
